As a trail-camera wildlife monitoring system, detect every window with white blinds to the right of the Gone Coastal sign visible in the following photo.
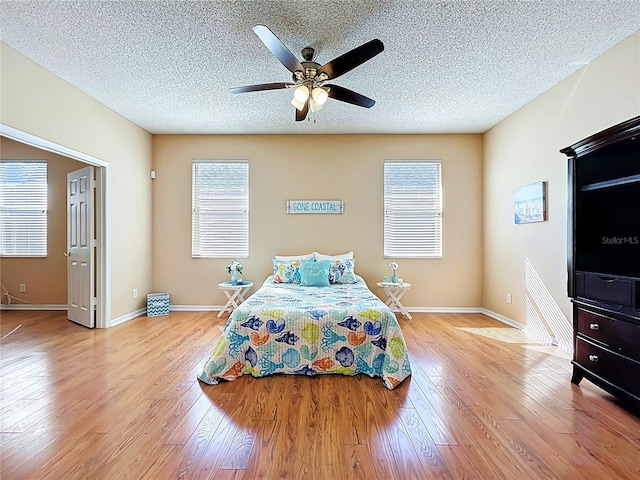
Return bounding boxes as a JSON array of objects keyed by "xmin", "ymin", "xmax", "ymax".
[{"xmin": 384, "ymin": 160, "xmax": 442, "ymax": 258}]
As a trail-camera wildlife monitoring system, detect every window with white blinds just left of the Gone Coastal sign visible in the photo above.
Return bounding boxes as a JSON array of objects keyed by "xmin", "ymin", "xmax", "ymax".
[{"xmin": 191, "ymin": 160, "xmax": 249, "ymax": 258}]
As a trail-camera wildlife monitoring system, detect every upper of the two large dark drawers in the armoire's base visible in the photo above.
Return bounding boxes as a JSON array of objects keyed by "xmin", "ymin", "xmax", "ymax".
[{"xmin": 577, "ymin": 308, "xmax": 640, "ymax": 361}]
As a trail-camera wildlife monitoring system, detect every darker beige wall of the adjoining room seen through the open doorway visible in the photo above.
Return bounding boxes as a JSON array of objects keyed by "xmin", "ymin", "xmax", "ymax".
[{"xmin": 0, "ymin": 137, "xmax": 85, "ymax": 305}]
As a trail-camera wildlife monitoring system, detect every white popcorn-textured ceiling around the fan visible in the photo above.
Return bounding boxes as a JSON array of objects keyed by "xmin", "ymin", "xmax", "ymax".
[{"xmin": 0, "ymin": 0, "xmax": 640, "ymax": 133}]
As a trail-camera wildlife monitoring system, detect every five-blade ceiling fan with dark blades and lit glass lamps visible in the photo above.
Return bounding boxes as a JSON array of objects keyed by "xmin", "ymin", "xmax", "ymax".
[{"xmin": 229, "ymin": 25, "xmax": 384, "ymax": 122}]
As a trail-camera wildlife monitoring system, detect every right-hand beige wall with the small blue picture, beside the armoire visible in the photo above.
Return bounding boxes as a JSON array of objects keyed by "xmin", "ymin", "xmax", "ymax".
[{"xmin": 482, "ymin": 33, "xmax": 640, "ymax": 323}]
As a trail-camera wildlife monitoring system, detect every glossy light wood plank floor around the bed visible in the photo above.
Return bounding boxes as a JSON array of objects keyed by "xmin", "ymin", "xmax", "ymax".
[{"xmin": 0, "ymin": 312, "xmax": 640, "ymax": 480}]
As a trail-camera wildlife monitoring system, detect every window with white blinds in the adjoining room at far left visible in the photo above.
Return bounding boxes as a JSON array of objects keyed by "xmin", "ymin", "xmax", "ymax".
[{"xmin": 0, "ymin": 160, "xmax": 48, "ymax": 257}]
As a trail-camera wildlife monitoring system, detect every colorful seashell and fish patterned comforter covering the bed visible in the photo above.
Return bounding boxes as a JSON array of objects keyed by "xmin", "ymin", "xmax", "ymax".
[{"xmin": 198, "ymin": 276, "xmax": 411, "ymax": 389}]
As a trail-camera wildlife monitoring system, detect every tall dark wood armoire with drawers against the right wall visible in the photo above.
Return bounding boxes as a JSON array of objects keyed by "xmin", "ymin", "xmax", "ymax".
[{"xmin": 560, "ymin": 117, "xmax": 640, "ymax": 402}]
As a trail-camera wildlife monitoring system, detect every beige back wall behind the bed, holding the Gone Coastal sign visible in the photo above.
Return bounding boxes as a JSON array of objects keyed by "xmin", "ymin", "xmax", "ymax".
[{"xmin": 153, "ymin": 135, "xmax": 482, "ymax": 307}]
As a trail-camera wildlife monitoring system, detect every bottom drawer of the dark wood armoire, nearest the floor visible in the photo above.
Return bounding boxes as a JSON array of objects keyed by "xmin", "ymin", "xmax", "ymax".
[{"xmin": 575, "ymin": 338, "xmax": 640, "ymax": 397}]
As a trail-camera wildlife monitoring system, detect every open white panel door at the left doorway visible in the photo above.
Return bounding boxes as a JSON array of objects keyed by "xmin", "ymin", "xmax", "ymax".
[{"xmin": 65, "ymin": 167, "xmax": 95, "ymax": 328}]
